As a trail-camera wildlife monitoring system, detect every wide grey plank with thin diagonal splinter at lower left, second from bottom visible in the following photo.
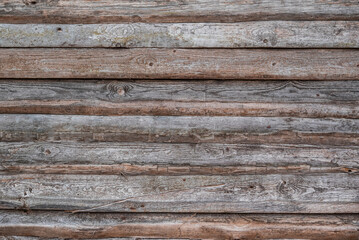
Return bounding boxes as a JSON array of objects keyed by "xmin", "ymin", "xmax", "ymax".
[{"xmin": 0, "ymin": 173, "xmax": 359, "ymax": 213}]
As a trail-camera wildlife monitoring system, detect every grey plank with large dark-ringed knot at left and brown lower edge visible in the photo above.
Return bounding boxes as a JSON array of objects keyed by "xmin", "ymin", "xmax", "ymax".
[{"xmin": 0, "ymin": 80, "xmax": 359, "ymax": 118}]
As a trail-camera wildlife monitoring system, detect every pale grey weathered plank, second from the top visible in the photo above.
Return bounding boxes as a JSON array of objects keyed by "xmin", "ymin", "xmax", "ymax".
[{"xmin": 0, "ymin": 21, "xmax": 359, "ymax": 48}]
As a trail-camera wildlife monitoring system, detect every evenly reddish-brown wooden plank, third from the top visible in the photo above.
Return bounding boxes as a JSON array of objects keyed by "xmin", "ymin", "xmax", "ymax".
[{"xmin": 0, "ymin": 48, "xmax": 359, "ymax": 80}]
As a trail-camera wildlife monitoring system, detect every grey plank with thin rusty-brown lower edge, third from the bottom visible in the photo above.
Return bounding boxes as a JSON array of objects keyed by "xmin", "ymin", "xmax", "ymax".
[{"xmin": 0, "ymin": 142, "xmax": 359, "ymax": 176}]
